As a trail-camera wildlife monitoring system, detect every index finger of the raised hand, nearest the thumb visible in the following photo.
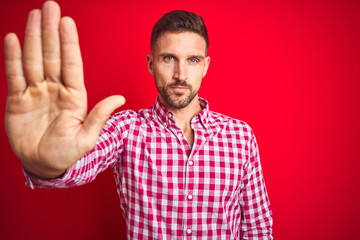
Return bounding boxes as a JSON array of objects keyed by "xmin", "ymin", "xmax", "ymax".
[{"xmin": 60, "ymin": 17, "xmax": 85, "ymax": 90}]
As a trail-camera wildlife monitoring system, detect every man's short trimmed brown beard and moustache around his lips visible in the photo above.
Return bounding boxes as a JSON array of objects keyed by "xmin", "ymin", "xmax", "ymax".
[{"xmin": 156, "ymin": 80, "xmax": 200, "ymax": 109}]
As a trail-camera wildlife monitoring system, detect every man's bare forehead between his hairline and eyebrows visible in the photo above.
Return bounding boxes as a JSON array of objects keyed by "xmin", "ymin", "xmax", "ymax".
[{"xmin": 154, "ymin": 32, "xmax": 206, "ymax": 55}]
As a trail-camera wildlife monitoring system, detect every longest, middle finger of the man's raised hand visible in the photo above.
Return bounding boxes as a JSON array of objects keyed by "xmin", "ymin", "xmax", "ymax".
[{"xmin": 41, "ymin": 1, "xmax": 61, "ymax": 81}]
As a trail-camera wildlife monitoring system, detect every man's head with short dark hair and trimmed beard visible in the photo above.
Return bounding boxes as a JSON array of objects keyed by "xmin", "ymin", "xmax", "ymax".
[{"xmin": 147, "ymin": 11, "xmax": 210, "ymax": 109}]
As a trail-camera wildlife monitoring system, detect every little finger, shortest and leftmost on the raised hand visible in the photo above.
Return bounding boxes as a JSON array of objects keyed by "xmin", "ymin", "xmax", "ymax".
[{"xmin": 4, "ymin": 33, "xmax": 27, "ymax": 96}]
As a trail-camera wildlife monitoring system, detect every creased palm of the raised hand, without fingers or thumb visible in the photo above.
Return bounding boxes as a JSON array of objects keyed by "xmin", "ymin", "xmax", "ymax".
[{"xmin": 5, "ymin": 81, "xmax": 87, "ymax": 169}]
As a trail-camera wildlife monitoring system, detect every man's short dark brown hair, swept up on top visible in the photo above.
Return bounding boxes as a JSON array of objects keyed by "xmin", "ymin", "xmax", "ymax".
[{"xmin": 151, "ymin": 10, "xmax": 209, "ymax": 52}]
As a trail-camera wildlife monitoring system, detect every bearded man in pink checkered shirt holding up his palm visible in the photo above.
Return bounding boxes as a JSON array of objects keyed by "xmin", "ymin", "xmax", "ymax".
[{"xmin": 5, "ymin": 1, "xmax": 272, "ymax": 239}]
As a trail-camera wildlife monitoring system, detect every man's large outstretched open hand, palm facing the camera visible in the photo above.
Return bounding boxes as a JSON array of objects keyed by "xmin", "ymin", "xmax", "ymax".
[{"xmin": 5, "ymin": 1, "xmax": 125, "ymax": 178}]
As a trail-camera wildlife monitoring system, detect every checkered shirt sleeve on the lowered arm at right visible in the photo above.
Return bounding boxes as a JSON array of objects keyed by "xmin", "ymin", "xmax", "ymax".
[{"xmin": 239, "ymin": 131, "xmax": 273, "ymax": 240}]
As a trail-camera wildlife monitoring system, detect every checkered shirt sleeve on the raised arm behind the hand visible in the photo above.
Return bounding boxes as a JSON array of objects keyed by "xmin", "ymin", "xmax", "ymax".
[{"xmin": 23, "ymin": 110, "xmax": 135, "ymax": 189}]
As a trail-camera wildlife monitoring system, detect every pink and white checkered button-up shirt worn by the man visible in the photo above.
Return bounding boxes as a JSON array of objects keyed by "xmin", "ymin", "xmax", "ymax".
[{"xmin": 25, "ymin": 99, "xmax": 273, "ymax": 240}]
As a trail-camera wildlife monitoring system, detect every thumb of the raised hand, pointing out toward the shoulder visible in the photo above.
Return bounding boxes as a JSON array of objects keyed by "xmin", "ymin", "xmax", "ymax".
[{"xmin": 83, "ymin": 95, "xmax": 125, "ymax": 139}]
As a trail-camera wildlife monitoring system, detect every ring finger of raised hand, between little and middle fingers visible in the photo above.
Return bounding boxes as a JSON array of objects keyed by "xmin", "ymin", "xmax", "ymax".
[{"xmin": 23, "ymin": 9, "xmax": 44, "ymax": 86}]
